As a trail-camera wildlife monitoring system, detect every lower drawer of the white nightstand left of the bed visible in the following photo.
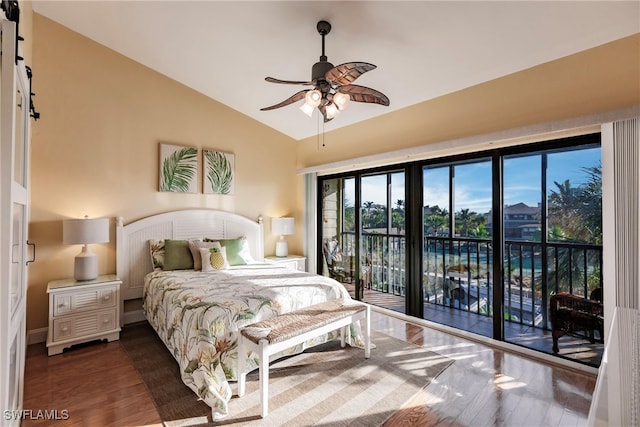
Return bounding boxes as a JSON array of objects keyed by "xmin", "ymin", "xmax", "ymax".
[{"xmin": 53, "ymin": 309, "xmax": 116, "ymax": 341}]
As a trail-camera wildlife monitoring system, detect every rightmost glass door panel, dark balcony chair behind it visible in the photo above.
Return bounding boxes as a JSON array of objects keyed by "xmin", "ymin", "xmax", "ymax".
[{"xmin": 503, "ymin": 145, "xmax": 604, "ymax": 365}]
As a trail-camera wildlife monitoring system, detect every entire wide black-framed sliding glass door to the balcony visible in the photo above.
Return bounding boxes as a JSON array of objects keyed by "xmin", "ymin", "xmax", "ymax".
[{"xmin": 319, "ymin": 135, "xmax": 603, "ymax": 366}]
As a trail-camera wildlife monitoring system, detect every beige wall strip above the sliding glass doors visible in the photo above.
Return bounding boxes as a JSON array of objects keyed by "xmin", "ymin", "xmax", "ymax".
[{"xmin": 298, "ymin": 34, "xmax": 640, "ymax": 169}]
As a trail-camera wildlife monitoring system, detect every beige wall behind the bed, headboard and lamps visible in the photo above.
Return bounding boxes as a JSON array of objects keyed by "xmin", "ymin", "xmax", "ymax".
[{"xmin": 27, "ymin": 14, "xmax": 302, "ymax": 330}]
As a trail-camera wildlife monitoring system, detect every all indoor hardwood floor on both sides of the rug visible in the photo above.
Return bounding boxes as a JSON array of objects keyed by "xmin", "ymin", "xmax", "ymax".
[{"xmin": 22, "ymin": 311, "xmax": 596, "ymax": 426}]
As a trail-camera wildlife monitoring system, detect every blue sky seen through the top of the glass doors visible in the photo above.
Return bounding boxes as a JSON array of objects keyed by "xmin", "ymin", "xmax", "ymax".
[{"xmin": 346, "ymin": 148, "xmax": 600, "ymax": 213}]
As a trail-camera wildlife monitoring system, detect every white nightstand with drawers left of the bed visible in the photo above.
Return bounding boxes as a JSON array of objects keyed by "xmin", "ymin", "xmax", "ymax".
[{"xmin": 47, "ymin": 274, "xmax": 122, "ymax": 356}]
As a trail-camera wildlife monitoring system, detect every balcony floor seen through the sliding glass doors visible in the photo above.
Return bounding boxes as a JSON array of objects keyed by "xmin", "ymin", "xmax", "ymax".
[{"xmin": 344, "ymin": 283, "xmax": 604, "ymax": 367}]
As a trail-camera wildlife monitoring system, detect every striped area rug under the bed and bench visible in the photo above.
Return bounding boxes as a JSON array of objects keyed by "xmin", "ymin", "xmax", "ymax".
[{"xmin": 120, "ymin": 322, "xmax": 453, "ymax": 426}]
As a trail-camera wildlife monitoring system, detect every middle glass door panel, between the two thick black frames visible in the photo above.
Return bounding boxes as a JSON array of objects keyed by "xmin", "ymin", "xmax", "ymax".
[{"xmin": 422, "ymin": 159, "xmax": 493, "ymax": 336}]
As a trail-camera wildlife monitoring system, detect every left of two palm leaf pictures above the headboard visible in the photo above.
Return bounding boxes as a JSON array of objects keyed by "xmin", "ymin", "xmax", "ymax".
[{"xmin": 160, "ymin": 145, "xmax": 198, "ymax": 193}]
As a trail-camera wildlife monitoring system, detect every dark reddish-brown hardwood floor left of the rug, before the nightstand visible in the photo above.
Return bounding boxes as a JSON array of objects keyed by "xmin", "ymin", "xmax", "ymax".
[{"xmin": 22, "ymin": 340, "xmax": 162, "ymax": 426}]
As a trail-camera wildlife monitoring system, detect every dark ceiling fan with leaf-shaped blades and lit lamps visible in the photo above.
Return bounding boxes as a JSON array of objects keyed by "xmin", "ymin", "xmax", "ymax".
[{"xmin": 260, "ymin": 21, "xmax": 389, "ymax": 123}]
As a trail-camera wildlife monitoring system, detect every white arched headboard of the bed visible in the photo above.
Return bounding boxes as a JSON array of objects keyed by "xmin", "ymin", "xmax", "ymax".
[{"xmin": 116, "ymin": 209, "xmax": 264, "ymax": 300}]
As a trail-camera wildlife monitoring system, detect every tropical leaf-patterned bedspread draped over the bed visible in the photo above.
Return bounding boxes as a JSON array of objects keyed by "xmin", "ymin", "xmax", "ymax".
[{"xmin": 143, "ymin": 264, "xmax": 363, "ymax": 419}]
